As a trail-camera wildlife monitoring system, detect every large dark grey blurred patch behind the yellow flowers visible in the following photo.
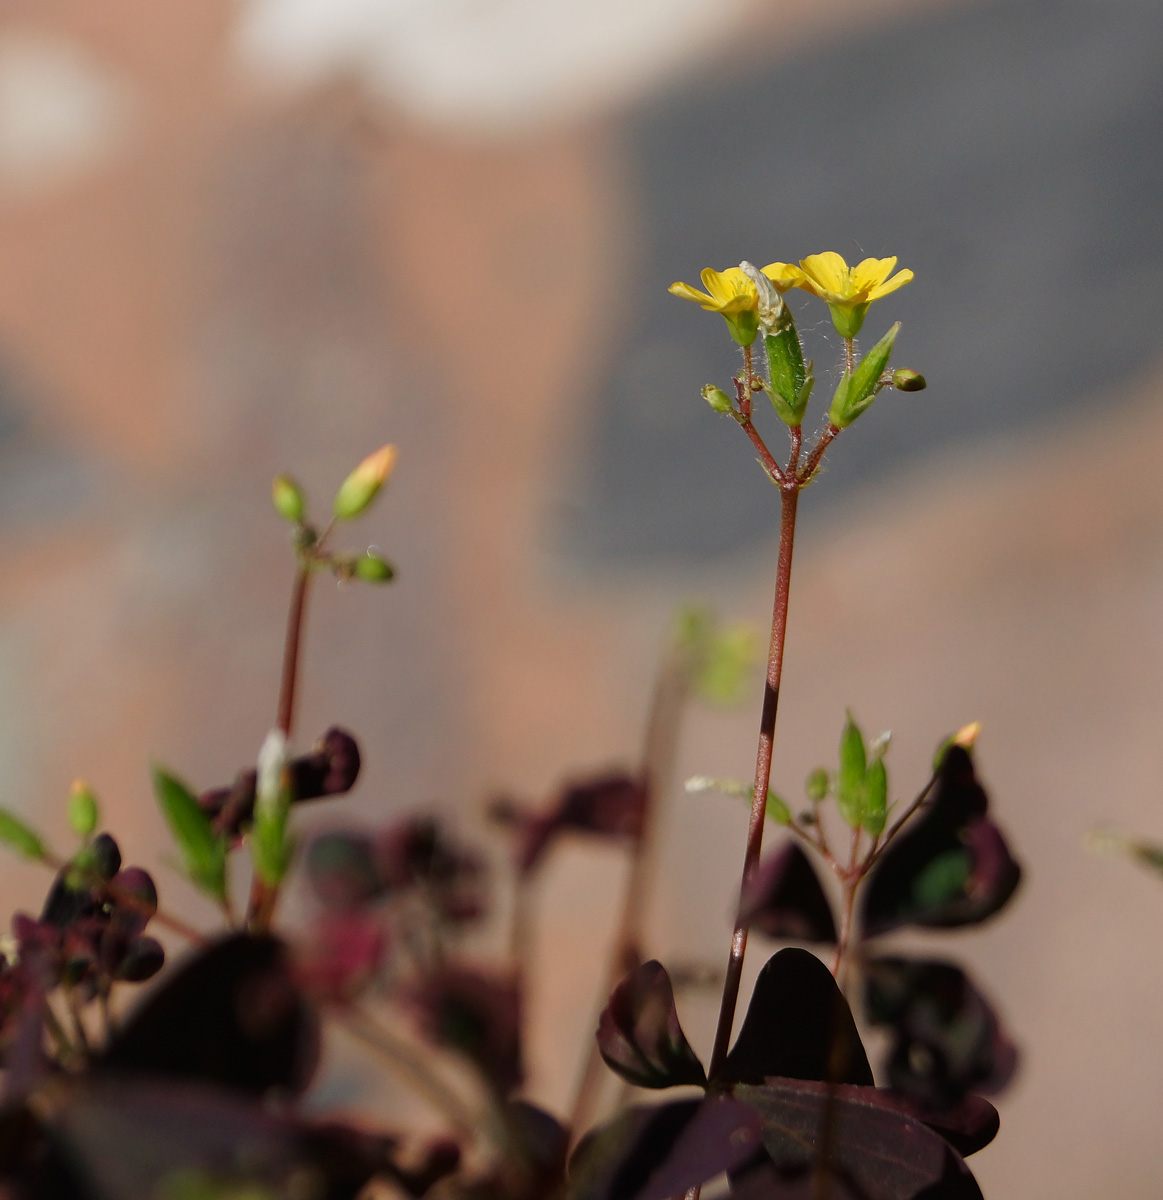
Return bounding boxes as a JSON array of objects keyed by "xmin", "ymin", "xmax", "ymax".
[{"xmin": 578, "ymin": 0, "xmax": 1163, "ymax": 564}]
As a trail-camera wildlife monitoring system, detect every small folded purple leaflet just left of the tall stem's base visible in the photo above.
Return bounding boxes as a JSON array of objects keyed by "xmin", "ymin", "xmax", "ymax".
[{"xmin": 598, "ymin": 959, "xmax": 707, "ymax": 1087}]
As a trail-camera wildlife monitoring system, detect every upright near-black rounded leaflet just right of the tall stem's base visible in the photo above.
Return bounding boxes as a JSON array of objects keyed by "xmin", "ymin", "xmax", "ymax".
[{"xmin": 714, "ymin": 948, "xmax": 873, "ymax": 1085}]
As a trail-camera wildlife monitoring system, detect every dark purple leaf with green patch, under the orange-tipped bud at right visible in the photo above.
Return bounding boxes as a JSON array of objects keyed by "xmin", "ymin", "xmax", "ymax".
[{"xmin": 861, "ymin": 745, "xmax": 1021, "ymax": 937}]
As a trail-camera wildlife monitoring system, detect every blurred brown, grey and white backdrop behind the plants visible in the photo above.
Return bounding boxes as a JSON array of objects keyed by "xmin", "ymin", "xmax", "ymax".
[{"xmin": 0, "ymin": 0, "xmax": 1163, "ymax": 1200}]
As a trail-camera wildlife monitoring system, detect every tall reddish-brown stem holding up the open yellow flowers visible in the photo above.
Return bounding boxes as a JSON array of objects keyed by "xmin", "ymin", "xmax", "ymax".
[{"xmin": 708, "ymin": 485, "xmax": 799, "ymax": 1080}]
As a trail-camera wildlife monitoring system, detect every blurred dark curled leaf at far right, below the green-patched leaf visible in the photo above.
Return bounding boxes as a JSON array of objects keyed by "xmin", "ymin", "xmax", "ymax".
[{"xmin": 864, "ymin": 958, "xmax": 1018, "ymax": 1109}]
